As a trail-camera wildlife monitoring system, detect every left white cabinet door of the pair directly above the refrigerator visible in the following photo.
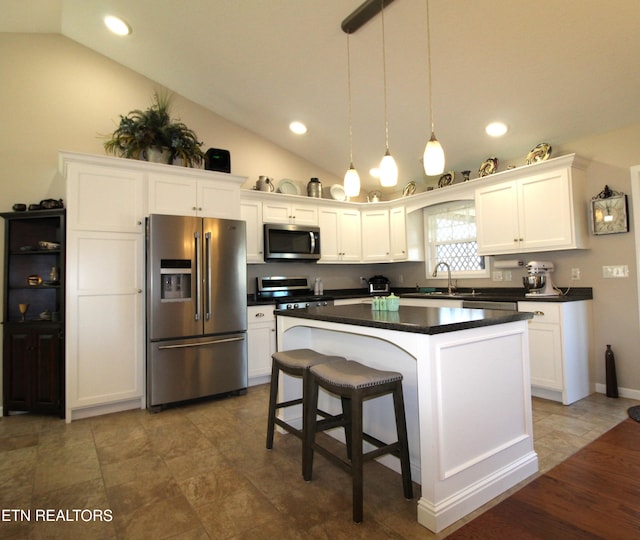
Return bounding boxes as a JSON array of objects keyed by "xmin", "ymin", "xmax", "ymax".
[{"xmin": 149, "ymin": 172, "xmax": 198, "ymax": 216}]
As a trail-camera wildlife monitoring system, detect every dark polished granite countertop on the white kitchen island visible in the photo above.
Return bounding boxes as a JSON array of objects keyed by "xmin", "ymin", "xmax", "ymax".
[{"xmin": 275, "ymin": 304, "xmax": 533, "ymax": 335}]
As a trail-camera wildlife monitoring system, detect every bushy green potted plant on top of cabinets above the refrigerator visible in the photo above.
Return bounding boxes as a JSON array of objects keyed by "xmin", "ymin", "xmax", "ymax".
[{"xmin": 104, "ymin": 92, "xmax": 204, "ymax": 167}]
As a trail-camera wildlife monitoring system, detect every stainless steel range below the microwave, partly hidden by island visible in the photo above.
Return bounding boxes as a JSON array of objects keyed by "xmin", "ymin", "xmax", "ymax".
[{"xmin": 256, "ymin": 276, "xmax": 333, "ymax": 309}]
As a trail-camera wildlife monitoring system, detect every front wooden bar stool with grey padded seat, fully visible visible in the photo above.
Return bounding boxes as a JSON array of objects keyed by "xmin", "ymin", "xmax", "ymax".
[{"xmin": 302, "ymin": 361, "xmax": 413, "ymax": 523}]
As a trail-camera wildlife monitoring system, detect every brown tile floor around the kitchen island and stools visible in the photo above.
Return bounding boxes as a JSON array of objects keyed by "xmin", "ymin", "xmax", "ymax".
[{"xmin": 0, "ymin": 385, "xmax": 638, "ymax": 540}]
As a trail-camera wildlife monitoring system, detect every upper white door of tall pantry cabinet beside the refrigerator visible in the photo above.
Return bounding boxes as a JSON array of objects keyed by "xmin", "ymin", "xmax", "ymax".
[{"xmin": 67, "ymin": 162, "xmax": 146, "ymax": 233}]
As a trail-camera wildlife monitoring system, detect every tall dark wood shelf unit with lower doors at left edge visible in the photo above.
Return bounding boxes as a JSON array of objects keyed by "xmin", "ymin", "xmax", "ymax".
[{"xmin": 0, "ymin": 209, "xmax": 66, "ymax": 418}]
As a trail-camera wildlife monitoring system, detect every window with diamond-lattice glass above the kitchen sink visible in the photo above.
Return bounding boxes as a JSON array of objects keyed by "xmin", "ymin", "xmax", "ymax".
[{"xmin": 424, "ymin": 201, "xmax": 489, "ymax": 278}]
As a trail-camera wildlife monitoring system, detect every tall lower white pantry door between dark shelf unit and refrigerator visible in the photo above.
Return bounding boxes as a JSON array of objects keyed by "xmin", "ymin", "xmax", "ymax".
[{"xmin": 66, "ymin": 232, "xmax": 144, "ymax": 414}]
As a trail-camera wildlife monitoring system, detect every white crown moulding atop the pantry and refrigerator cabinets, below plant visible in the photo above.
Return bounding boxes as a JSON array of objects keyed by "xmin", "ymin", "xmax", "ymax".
[{"xmin": 58, "ymin": 151, "xmax": 246, "ymax": 186}]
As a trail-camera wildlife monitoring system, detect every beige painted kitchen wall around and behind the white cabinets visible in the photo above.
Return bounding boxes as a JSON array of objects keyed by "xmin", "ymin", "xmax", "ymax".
[{"xmin": 0, "ymin": 34, "xmax": 640, "ymax": 395}]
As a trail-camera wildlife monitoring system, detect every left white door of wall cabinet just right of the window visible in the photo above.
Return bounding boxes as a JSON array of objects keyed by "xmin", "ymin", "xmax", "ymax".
[{"xmin": 476, "ymin": 182, "xmax": 520, "ymax": 255}]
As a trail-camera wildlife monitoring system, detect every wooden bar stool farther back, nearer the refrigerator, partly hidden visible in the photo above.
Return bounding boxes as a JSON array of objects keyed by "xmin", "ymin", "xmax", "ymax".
[{"xmin": 267, "ymin": 349, "xmax": 346, "ymax": 468}]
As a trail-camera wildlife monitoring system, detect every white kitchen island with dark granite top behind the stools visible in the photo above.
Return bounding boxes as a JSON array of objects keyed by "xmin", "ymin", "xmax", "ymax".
[{"xmin": 276, "ymin": 304, "xmax": 538, "ymax": 532}]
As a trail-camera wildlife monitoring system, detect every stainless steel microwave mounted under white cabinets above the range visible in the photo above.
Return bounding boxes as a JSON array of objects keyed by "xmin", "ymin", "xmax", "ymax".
[{"xmin": 264, "ymin": 223, "xmax": 320, "ymax": 262}]
